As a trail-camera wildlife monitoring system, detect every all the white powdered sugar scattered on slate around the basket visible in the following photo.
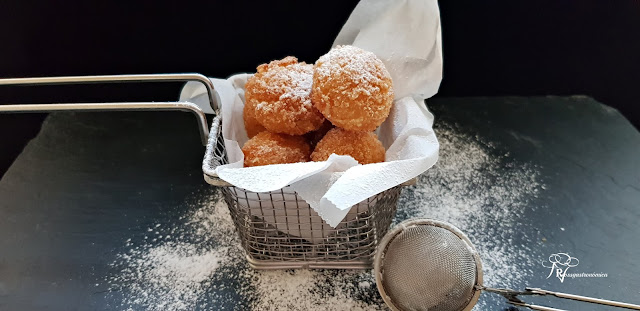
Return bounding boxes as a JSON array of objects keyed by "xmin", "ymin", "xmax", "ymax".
[{"xmin": 107, "ymin": 120, "xmax": 541, "ymax": 311}]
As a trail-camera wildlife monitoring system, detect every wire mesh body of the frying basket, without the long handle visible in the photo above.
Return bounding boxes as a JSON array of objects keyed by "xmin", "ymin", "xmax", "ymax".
[{"xmin": 203, "ymin": 117, "xmax": 402, "ymax": 269}]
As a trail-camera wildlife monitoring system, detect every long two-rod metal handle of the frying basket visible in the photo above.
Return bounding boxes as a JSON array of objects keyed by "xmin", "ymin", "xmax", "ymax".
[{"xmin": 0, "ymin": 73, "xmax": 220, "ymax": 146}]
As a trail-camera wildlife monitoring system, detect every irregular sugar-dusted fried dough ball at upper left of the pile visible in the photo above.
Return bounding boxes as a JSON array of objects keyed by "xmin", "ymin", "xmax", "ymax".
[{"xmin": 245, "ymin": 56, "xmax": 324, "ymax": 135}]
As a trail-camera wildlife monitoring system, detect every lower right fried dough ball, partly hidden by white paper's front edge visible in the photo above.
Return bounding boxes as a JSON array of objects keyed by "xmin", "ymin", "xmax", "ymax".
[{"xmin": 311, "ymin": 127, "xmax": 385, "ymax": 164}]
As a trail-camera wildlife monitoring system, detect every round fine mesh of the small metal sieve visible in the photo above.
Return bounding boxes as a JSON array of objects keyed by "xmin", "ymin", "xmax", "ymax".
[{"xmin": 378, "ymin": 224, "xmax": 478, "ymax": 311}]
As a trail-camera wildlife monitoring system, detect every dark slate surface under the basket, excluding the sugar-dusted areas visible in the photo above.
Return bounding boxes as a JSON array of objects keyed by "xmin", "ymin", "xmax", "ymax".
[{"xmin": 0, "ymin": 97, "xmax": 640, "ymax": 310}]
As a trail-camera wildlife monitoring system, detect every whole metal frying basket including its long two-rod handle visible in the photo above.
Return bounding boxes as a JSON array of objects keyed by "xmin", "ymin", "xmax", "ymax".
[{"xmin": 0, "ymin": 74, "xmax": 415, "ymax": 269}]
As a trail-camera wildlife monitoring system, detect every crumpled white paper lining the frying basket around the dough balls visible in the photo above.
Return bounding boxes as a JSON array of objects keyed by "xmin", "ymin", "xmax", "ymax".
[{"xmin": 180, "ymin": 0, "xmax": 442, "ymax": 227}]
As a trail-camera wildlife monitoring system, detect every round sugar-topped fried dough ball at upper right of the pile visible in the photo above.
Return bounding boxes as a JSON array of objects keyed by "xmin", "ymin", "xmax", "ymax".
[{"xmin": 311, "ymin": 45, "xmax": 393, "ymax": 131}]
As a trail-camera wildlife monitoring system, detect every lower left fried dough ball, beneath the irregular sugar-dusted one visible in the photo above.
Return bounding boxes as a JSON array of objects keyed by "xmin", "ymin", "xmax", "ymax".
[{"xmin": 242, "ymin": 131, "xmax": 311, "ymax": 167}]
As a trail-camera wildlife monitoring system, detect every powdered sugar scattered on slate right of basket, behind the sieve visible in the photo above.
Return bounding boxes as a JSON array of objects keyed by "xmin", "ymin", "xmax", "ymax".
[{"xmin": 397, "ymin": 123, "xmax": 542, "ymax": 310}]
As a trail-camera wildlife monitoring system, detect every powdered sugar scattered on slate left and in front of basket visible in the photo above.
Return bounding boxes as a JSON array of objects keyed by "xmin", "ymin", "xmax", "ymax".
[{"xmin": 107, "ymin": 192, "xmax": 384, "ymax": 311}]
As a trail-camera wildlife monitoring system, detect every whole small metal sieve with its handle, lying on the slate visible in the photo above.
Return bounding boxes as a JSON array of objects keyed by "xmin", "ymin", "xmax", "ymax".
[{"xmin": 374, "ymin": 219, "xmax": 640, "ymax": 311}]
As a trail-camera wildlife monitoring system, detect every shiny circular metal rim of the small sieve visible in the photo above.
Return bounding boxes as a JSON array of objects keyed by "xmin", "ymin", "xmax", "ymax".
[{"xmin": 373, "ymin": 218, "xmax": 483, "ymax": 311}]
